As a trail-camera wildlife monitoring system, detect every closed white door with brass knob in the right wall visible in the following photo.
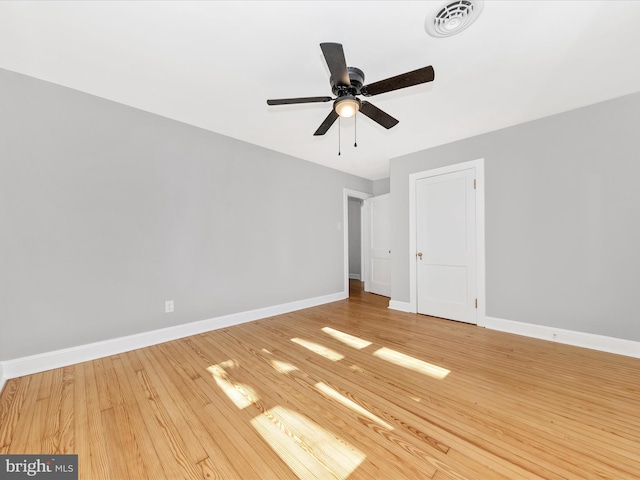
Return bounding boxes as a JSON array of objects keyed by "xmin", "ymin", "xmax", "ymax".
[{"xmin": 415, "ymin": 168, "xmax": 477, "ymax": 324}]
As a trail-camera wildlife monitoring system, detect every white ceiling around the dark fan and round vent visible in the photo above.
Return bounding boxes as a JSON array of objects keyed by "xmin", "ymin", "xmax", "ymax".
[{"xmin": 0, "ymin": 0, "xmax": 640, "ymax": 180}]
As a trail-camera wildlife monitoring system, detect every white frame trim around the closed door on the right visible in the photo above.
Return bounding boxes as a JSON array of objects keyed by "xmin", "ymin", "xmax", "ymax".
[{"xmin": 409, "ymin": 158, "xmax": 487, "ymax": 327}]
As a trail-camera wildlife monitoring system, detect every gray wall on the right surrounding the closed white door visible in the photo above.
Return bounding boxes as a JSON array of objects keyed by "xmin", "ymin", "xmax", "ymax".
[{"xmin": 390, "ymin": 94, "xmax": 640, "ymax": 341}]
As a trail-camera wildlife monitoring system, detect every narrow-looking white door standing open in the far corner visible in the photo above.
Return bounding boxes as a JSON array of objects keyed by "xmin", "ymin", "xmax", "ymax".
[{"xmin": 364, "ymin": 194, "xmax": 391, "ymax": 297}]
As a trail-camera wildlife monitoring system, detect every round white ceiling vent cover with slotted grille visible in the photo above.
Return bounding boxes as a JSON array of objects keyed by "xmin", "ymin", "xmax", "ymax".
[{"xmin": 425, "ymin": 0, "xmax": 484, "ymax": 37}]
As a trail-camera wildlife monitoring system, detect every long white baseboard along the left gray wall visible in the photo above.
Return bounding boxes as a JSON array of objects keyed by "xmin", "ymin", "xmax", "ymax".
[{"xmin": 0, "ymin": 292, "xmax": 348, "ymax": 392}]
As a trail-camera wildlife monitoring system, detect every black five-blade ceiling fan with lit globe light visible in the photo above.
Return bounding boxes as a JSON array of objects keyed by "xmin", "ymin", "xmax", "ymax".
[{"xmin": 267, "ymin": 43, "xmax": 435, "ymax": 135}]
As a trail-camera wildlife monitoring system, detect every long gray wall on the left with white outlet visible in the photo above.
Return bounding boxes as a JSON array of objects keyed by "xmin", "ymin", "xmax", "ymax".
[{"xmin": 0, "ymin": 70, "xmax": 372, "ymax": 360}]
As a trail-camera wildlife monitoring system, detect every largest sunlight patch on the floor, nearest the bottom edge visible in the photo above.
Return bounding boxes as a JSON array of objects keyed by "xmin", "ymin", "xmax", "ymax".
[{"xmin": 251, "ymin": 406, "xmax": 366, "ymax": 480}]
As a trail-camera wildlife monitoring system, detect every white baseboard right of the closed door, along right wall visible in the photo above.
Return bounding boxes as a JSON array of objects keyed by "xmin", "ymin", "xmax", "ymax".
[{"xmin": 484, "ymin": 317, "xmax": 640, "ymax": 358}]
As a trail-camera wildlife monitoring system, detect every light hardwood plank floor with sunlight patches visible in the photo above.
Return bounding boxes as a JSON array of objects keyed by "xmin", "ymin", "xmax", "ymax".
[{"xmin": 0, "ymin": 282, "xmax": 640, "ymax": 480}]
